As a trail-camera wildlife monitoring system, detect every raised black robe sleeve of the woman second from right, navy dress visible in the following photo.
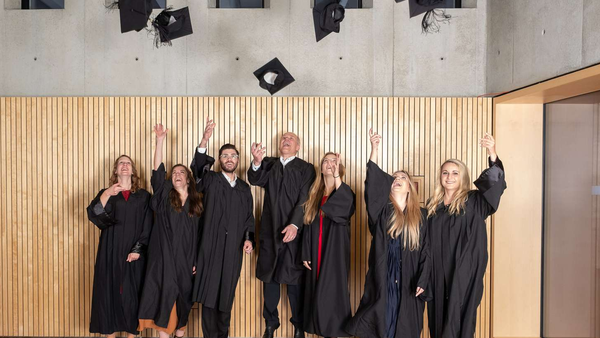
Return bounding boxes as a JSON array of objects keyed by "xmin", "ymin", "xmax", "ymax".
[{"xmin": 365, "ymin": 161, "xmax": 394, "ymax": 235}]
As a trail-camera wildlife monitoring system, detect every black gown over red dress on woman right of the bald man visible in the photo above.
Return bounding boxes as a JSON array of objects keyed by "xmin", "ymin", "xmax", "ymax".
[{"xmin": 302, "ymin": 183, "xmax": 355, "ymax": 337}]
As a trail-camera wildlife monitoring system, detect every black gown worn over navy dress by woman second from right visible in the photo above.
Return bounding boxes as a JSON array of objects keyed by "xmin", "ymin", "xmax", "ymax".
[{"xmin": 346, "ymin": 161, "xmax": 431, "ymax": 338}]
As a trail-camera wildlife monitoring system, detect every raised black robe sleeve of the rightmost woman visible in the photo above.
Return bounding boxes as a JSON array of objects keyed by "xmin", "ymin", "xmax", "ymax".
[{"xmin": 474, "ymin": 157, "xmax": 506, "ymax": 219}]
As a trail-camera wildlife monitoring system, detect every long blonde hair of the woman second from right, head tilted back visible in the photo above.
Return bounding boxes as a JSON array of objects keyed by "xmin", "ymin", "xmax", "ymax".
[{"xmin": 388, "ymin": 170, "xmax": 422, "ymax": 251}]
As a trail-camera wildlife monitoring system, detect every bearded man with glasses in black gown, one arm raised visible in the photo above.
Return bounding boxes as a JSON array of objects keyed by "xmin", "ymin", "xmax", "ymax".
[{"xmin": 190, "ymin": 119, "xmax": 254, "ymax": 338}]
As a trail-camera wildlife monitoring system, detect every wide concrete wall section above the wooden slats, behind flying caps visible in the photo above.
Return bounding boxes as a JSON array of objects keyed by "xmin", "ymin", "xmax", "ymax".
[{"xmin": 0, "ymin": 0, "xmax": 488, "ymax": 96}]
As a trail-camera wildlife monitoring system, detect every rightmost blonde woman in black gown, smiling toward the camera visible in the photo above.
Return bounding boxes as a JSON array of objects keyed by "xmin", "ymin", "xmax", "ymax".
[{"xmin": 427, "ymin": 134, "xmax": 506, "ymax": 338}]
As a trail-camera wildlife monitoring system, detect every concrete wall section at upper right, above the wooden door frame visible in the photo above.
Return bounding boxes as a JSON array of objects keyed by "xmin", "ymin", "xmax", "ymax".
[{"xmin": 486, "ymin": 0, "xmax": 600, "ymax": 92}]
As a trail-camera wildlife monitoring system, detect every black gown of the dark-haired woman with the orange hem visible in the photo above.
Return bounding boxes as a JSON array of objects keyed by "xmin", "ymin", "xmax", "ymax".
[{"xmin": 139, "ymin": 163, "xmax": 200, "ymax": 329}]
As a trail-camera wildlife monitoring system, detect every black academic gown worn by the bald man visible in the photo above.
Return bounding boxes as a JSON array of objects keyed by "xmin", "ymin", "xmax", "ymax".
[{"xmin": 248, "ymin": 157, "xmax": 315, "ymax": 285}]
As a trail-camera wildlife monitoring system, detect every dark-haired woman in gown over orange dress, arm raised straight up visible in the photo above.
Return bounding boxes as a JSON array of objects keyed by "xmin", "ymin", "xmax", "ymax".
[{"xmin": 139, "ymin": 124, "xmax": 202, "ymax": 338}]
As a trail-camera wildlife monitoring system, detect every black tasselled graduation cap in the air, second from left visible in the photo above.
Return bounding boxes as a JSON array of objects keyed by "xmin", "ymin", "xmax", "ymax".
[{"xmin": 152, "ymin": 7, "xmax": 193, "ymax": 47}]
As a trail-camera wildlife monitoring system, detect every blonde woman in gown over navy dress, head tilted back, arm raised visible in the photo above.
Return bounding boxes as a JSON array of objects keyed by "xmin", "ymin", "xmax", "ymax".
[{"xmin": 347, "ymin": 130, "xmax": 430, "ymax": 338}]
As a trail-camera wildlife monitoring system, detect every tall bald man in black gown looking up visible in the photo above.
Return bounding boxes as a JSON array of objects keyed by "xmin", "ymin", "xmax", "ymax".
[{"xmin": 248, "ymin": 133, "xmax": 315, "ymax": 338}]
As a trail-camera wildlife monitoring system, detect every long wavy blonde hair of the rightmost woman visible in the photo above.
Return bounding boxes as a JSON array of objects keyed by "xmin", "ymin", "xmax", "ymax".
[{"xmin": 427, "ymin": 159, "xmax": 471, "ymax": 217}]
